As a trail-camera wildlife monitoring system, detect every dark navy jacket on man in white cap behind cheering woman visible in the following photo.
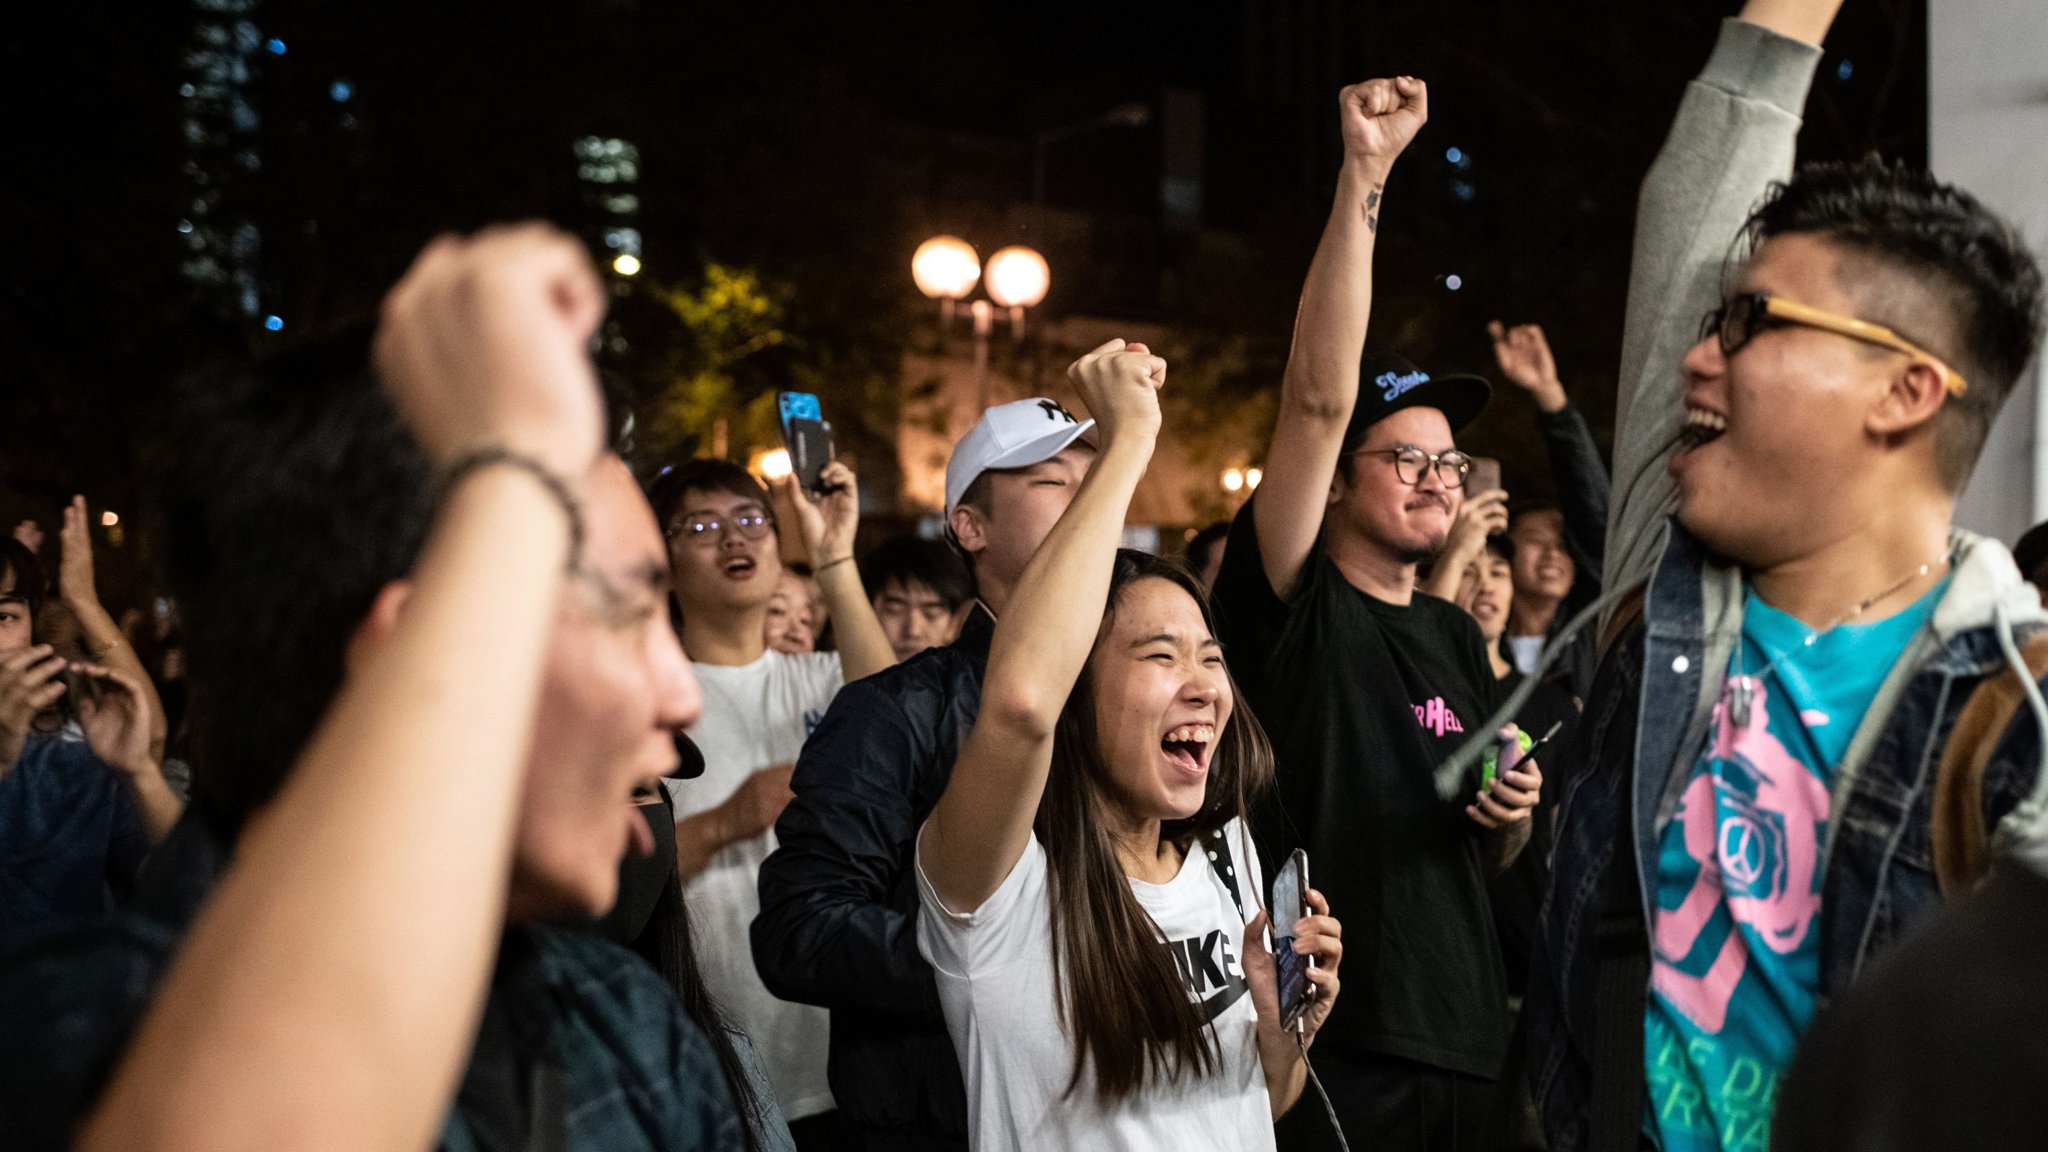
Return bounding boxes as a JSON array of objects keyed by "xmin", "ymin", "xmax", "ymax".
[{"xmin": 752, "ymin": 609, "xmax": 995, "ymax": 1152}]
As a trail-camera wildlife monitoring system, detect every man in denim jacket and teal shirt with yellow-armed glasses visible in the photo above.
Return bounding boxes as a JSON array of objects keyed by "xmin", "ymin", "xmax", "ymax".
[{"xmin": 1528, "ymin": 0, "xmax": 2048, "ymax": 1152}]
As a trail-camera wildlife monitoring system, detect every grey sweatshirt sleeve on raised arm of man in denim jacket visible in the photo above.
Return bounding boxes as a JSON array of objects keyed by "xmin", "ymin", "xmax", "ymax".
[{"xmin": 1604, "ymin": 20, "xmax": 1821, "ymax": 590}]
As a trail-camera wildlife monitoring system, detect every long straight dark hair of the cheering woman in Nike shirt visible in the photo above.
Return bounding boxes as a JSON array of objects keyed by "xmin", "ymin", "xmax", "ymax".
[{"xmin": 1034, "ymin": 549, "xmax": 1274, "ymax": 1101}]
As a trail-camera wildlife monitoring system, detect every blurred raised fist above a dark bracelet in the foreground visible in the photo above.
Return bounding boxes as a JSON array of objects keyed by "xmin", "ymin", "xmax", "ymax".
[{"xmin": 375, "ymin": 223, "xmax": 604, "ymax": 482}]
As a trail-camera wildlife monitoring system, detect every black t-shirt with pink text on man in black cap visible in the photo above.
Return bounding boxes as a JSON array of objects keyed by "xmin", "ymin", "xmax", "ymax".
[{"xmin": 1214, "ymin": 502, "xmax": 1509, "ymax": 1078}]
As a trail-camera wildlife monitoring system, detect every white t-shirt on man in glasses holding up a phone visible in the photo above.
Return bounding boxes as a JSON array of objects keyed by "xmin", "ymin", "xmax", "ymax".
[{"xmin": 666, "ymin": 652, "xmax": 846, "ymax": 1119}]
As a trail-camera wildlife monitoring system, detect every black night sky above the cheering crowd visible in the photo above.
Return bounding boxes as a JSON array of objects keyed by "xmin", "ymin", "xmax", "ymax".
[{"xmin": 0, "ymin": 0, "xmax": 1925, "ymax": 594}]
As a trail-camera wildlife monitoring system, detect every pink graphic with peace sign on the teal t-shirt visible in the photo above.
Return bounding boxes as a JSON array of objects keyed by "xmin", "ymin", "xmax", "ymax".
[{"xmin": 1651, "ymin": 672, "xmax": 1829, "ymax": 1033}]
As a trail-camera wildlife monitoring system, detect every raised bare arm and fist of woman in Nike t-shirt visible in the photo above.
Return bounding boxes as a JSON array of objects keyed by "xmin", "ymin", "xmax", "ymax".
[{"xmin": 920, "ymin": 340, "xmax": 1165, "ymax": 912}]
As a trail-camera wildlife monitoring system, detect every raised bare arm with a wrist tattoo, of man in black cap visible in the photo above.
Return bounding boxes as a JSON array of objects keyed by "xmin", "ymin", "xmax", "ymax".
[{"xmin": 1251, "ymin": 76, "xmax": 1430, "ymax": 599}]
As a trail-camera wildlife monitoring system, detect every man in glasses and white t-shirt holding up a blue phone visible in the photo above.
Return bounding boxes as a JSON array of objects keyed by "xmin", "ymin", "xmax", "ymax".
[{"xmin": 649, "ymin": 446, "xmax": 895, "ymax": 1148}]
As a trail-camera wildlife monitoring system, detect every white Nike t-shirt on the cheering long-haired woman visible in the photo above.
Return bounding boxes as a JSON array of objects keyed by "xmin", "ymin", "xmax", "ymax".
[{"xmin": 918, "ymin": 820, "xmax": 1274, "ymax": 1152}]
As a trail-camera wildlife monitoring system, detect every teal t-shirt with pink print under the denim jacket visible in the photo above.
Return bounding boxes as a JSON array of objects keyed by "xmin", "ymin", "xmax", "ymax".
[{"xmin": 1642, "ymin": 580, "xmax": 1948, "ymax": 1152}]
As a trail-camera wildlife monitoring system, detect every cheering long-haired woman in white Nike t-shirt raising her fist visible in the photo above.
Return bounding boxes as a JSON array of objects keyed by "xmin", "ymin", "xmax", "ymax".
[{"xmin": 918, "ymin": 340, "xmax": 1341, "ymax": 1152}]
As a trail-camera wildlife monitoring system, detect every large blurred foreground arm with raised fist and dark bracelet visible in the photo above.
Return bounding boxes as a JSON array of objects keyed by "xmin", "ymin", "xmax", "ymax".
[{"xmin": 80, "ymin": 228, "xmax": 604, "ymax": 1150}]
